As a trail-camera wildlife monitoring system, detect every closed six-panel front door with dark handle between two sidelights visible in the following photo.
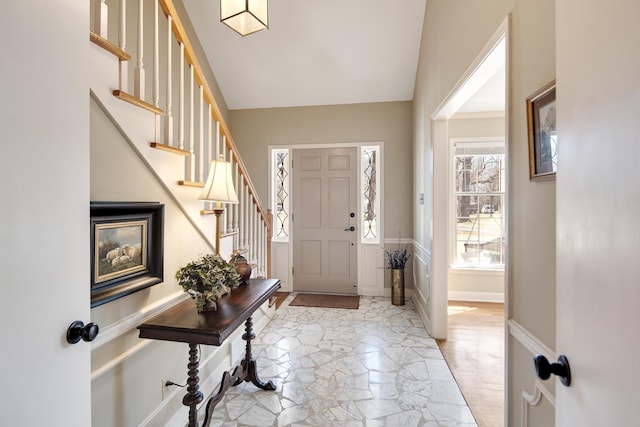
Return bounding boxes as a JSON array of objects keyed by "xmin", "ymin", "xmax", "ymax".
[{"xmin": 292, "ymin": 148, "xmax": 358, "ymax": 294}]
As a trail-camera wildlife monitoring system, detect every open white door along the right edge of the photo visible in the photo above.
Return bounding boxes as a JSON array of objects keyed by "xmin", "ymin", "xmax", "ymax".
[{"xmin": 556, "ymin": 0, "xmax": 640, "ymax": 427}]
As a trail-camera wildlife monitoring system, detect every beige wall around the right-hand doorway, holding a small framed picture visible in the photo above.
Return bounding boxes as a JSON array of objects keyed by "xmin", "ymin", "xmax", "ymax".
[{"xmin": 414, "ymin": 0, "xmax": 555, "ymax": 425}]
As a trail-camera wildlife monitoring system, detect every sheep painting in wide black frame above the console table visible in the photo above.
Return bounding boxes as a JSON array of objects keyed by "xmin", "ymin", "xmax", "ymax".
[{"xmin": 91, "ymin": 202, "xmax": 164, "ymax": 307}]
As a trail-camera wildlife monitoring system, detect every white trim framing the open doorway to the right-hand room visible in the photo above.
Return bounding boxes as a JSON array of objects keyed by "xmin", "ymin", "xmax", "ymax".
[{"xmin": 428, "ymin": 18, "xmax": 509, "ymax": 339}]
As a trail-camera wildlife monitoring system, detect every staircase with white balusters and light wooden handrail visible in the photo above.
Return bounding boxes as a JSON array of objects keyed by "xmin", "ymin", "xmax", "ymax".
[{"xmin": 89, "ymin": 0, "xmax": 272, "ymax": 277}]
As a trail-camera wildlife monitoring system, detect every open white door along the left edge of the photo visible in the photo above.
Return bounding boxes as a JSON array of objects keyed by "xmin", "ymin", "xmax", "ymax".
[{"xmin": 0, "ymin": 0, "xmax": 90, "ymax": 427}]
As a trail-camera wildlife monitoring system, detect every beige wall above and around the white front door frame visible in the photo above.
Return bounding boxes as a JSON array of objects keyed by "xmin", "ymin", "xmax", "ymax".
[{"xmin": 230, "ymin": 102, "xmax": 413, "ymax": 239}]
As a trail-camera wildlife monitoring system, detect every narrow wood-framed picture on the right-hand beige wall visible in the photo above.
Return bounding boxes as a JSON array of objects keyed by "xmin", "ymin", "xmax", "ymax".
[{"xmin": 526, "ymin": 80, "xmax": 558, "ymax": 180}]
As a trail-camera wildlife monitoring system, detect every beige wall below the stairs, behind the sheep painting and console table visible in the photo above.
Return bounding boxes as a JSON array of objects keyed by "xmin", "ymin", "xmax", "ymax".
[{"xmin": 90, "ymin": 99, "xmax": 272, "ymax": 427}]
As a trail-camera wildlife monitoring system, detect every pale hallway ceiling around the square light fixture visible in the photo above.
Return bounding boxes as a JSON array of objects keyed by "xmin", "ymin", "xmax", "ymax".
[{"xmin": 184, "ymin": 0, "xmax": 504, "ymax": 111}]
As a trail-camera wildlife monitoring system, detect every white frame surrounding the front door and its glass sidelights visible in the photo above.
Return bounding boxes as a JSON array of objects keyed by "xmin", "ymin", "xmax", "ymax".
[{"xmin": 268, "ymin": 141, "xmax": 385, "ymax": 296}]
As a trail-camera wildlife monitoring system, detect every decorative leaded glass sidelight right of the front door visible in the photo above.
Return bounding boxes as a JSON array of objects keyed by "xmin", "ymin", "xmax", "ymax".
[{"xmin": 360, "ymin": 146, "xmax": 380, "ymax": 243}]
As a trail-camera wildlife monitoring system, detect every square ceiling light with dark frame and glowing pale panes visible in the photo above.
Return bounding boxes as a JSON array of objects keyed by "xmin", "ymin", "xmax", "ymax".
[{"xmin": 220, "ymin": 0, "xmax": 269, "ymax": 37}]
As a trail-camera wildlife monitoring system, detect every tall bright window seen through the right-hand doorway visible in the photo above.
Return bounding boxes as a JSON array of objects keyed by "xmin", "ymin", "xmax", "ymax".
[{"xmin": 454, "ymin": 143, "xmax": 504, "ymax": 268}]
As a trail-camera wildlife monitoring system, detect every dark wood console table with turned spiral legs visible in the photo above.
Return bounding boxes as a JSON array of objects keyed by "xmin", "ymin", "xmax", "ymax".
[{"xmin": 138, "ymin": 279, "xmax": 280, "ymax": 427}]
